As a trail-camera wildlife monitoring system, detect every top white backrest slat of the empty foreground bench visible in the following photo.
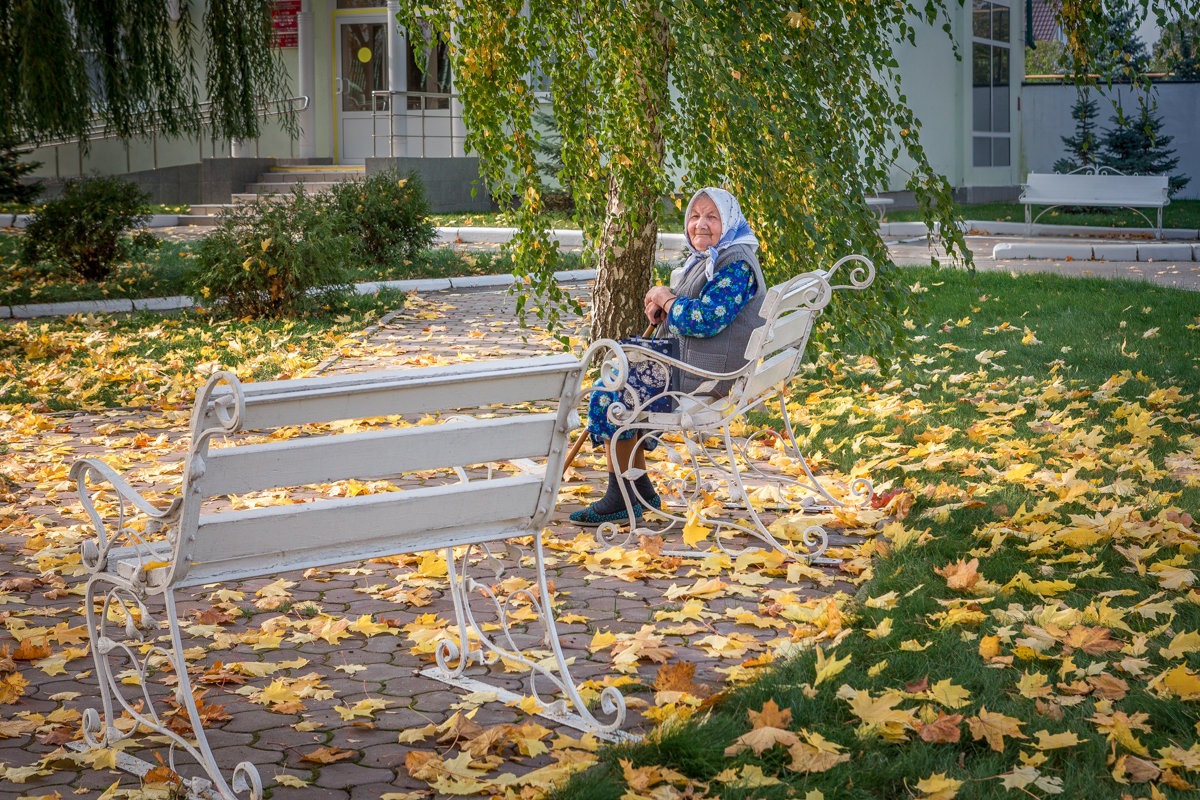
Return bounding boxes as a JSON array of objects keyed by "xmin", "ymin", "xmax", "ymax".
[{"xmin": 200, "ymin": 355, "xmax": 581, "ymax": 435}]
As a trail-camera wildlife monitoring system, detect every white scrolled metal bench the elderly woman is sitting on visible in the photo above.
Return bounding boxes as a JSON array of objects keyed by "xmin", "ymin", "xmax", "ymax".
[{"xmin": 598, "ymin": 255, "xmax": 875, "ymax": 561}]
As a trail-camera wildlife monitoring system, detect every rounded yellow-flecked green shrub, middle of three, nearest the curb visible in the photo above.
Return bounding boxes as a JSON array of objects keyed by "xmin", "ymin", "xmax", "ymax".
[{"xmin": 190, "ymin": 186, "xmax": 354, "ymax": 317}]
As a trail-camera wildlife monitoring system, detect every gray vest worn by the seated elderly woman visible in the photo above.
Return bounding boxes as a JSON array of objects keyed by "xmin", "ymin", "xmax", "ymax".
[{"xmin": 659, "ymin": 245, "xmax": 767, "ymax": 396}]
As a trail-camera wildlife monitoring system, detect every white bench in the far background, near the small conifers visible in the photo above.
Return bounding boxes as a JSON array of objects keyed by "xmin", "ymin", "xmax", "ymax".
[{"xmin": 1020, "ymin": 167, "xmax": 1171, "ymax": 239}]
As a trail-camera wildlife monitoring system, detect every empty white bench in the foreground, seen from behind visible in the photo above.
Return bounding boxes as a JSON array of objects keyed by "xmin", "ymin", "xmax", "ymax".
[{"xmin": 71, "ymin": 341, "xmax": 626, "ymax": 800}]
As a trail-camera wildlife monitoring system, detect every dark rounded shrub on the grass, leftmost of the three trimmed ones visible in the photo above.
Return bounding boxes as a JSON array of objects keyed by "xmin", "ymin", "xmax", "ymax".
[{"xmin": 20, "ymin": 178, "xmax": 150, "ymax": 281}]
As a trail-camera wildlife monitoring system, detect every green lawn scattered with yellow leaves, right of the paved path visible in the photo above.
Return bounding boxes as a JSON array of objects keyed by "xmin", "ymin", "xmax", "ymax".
[{"xmin": 558, "ymin": 271, "xmax": 1200, "ymax": 800}]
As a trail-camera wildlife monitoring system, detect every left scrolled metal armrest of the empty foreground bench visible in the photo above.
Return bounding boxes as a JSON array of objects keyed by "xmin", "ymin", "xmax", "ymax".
[{"xmin": 71, "ymin": 458, "xmax": 182, "ymax": 572}]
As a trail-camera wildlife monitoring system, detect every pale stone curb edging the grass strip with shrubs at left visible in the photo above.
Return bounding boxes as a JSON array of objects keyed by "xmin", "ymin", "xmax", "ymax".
[{"xmin": 0, "ymin": 270, "xmax": 596, "ymax": 319}]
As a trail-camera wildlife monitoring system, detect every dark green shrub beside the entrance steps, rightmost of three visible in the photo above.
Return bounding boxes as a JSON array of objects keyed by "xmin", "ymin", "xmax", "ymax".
[{"xmin": 334, "ymin": 169, "xmax": 437, "ymax": 266}]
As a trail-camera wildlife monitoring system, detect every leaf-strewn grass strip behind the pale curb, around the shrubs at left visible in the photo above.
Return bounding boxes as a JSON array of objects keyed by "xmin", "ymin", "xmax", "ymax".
[{"xmin": 0, "ymin": 234, "xmax": 582, "ymax": 306}]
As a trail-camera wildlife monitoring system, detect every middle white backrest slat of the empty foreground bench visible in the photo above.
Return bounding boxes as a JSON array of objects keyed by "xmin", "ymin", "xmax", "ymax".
[{"xmin": 197, "ymin": 414, "xmax": 558, "ymax": 498}]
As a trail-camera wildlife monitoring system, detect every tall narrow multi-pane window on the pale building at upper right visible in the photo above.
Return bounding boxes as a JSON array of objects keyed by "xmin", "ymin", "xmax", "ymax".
[{"xmin": 971, "ymin": 0, "xmax": 1013, "ymax": 167}]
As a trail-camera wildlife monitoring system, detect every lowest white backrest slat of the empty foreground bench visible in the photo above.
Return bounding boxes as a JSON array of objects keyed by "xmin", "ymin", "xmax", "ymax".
[{"xmin": 175, "ymin": 474, "xmax": 541, "ymax": 587}]
